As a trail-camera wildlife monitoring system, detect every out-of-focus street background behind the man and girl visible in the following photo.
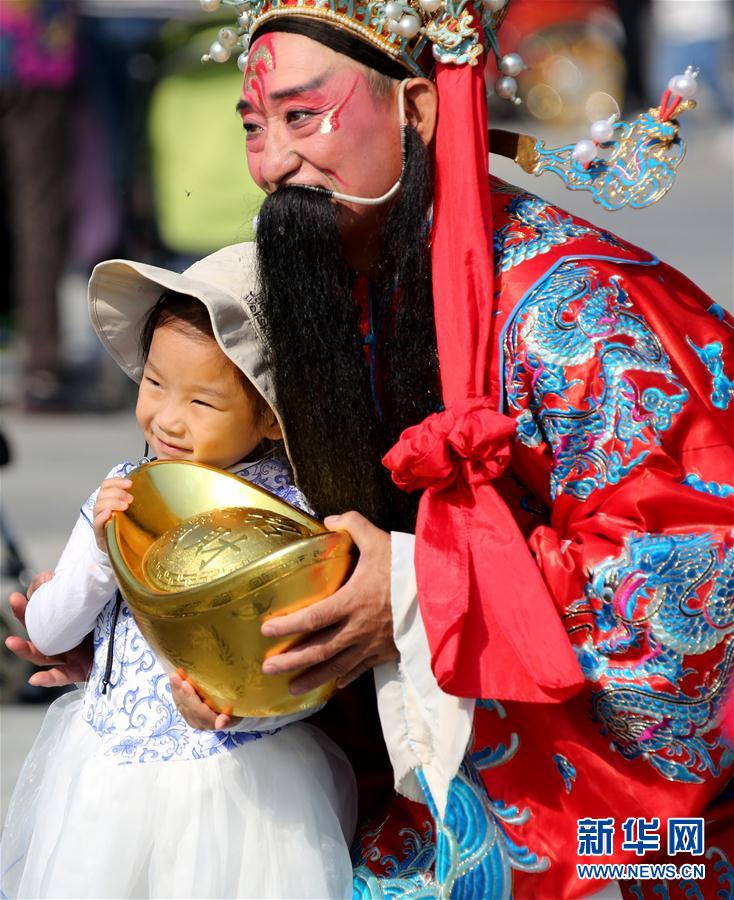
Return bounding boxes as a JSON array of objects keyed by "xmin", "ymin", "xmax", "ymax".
[{"xmin": 0, "ymin": 0, "xmax": 734, "ymax": 809}]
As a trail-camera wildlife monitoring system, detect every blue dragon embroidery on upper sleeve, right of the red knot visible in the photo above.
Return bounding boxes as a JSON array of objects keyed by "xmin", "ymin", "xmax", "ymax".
[{"xmin": 505, "ymin": 260, "xmax": 688, "ymax": 500}]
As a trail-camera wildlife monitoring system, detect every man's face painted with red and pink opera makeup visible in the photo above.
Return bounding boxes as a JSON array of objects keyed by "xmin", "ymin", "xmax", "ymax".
[{"xmin": 239, "ymin": 33, "xmax": 401, "ymax": 206}]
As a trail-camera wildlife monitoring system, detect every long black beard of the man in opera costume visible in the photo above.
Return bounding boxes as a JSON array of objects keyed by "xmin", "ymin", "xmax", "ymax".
[{"xmin": 257, "ymin": 129, "xmax": 440, "ymax": 530}]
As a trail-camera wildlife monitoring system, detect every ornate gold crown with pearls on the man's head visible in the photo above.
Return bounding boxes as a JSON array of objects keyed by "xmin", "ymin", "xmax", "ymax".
[{"xmin": 200, "ymin": 0, "xmax": 511, "ymax": 77}]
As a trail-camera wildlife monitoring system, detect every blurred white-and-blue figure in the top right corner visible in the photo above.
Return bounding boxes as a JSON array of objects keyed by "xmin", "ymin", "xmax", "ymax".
[{"xmin": 651, "ymin": 0, "xmax": 734, "ymax": 121}]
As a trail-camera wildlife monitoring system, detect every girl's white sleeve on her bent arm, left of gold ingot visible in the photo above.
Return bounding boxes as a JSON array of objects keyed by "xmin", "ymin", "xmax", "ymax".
[{"xmin": 25, "ymin": 516, "xmax": 116, "ymax": 656}]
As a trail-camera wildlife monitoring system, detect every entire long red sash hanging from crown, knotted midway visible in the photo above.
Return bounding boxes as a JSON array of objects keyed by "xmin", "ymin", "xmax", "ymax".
[{"xmin": 383, "ymin": 54, "xmax": 583, "ymax": 702}]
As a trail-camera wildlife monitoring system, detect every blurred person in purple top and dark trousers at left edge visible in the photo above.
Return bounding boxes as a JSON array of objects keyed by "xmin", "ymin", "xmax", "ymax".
[{"xmin": 0, "ymin": 0, "xmax": 77, "ymax": 411}]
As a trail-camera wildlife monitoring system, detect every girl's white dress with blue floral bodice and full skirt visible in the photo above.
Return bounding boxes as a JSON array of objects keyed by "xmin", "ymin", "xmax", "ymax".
[{"xmin": 0, "ymin": 459, "xmax": 356, "ymax": 898}]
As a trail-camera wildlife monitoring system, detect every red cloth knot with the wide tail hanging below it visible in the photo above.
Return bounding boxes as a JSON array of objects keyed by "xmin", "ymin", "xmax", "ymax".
[{"xmin": 383, "ymin": 397, "xmax": 583, "ymax": 703}]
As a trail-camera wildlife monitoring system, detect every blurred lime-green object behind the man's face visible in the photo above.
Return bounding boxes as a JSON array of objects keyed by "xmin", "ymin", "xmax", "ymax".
[{"xmin": 148, "ymin": 29, "xmax": 264, "ymax": 255}]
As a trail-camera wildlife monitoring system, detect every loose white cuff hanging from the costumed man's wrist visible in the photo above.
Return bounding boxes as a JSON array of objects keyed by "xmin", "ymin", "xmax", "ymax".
[{"xmin": 374, "ymin": 532, "xmax": 474, "ymax": 816}]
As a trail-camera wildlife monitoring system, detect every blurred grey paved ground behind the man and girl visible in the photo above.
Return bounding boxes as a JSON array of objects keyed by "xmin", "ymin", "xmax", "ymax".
[{"xmin": 0, "ymin": 128, "xmax": 734, "ymax": 828}]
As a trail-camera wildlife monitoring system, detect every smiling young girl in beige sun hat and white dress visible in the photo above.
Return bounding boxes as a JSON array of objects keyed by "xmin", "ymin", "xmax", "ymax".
[{"xmin": 2, "ymin": 245, "xmax": 356, "ymax": 898}]
